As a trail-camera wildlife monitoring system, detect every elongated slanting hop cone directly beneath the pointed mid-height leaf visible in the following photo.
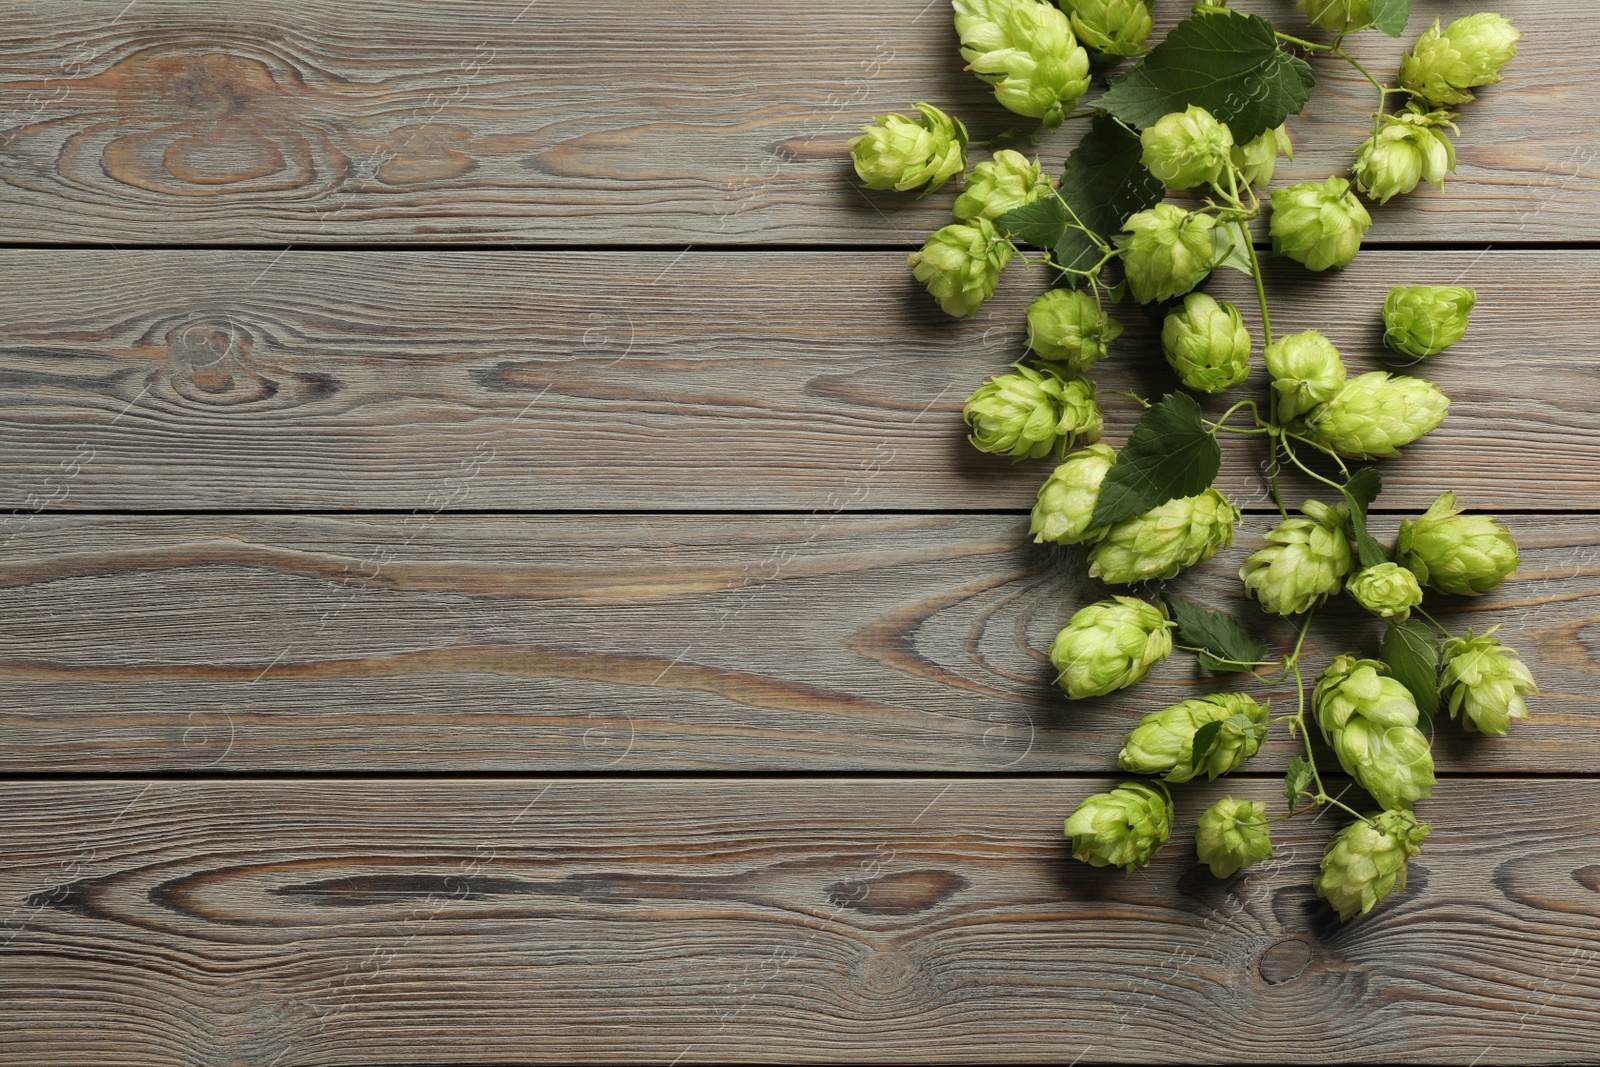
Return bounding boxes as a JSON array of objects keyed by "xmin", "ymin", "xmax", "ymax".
[{"xmin": 1090, "ymin": 490, "xmax": 1240, "ymax": 585}]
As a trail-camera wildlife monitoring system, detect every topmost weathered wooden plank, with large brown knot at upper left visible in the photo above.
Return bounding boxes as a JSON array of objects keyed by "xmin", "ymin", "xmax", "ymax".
[{"xmin": 0, "ymin": 0, "xmax": 1600, "ymax": 246}]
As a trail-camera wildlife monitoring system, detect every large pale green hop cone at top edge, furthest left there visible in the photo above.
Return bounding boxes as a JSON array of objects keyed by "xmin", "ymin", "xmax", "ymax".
[{"xmin": 954, "ymin": 0, "xmax": 1090, "ymax": 130}]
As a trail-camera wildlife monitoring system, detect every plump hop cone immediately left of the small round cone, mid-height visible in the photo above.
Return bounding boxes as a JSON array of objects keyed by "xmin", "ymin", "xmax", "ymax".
[{"xmin": 1238, "ymin": 501, "xmax": 1355, "ymax": 616}]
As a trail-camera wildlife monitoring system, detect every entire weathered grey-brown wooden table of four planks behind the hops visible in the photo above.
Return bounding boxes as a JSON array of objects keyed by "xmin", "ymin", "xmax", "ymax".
[{"xmin": 0, "ymin": 0, "xmax": 1600, "ymax": 1067}]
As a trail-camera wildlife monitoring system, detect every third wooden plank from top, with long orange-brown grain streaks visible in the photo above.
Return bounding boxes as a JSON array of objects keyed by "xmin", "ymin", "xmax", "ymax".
[{"xmin": 0, "ymin": 514, "xmax": 1600, "ymax": 774}]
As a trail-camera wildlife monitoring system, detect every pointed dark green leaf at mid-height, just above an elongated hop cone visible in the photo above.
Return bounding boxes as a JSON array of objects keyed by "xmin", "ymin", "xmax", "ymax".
[{"xmin": 1090, "ymin": 394, "xmax": 1222, "ymax": 528}]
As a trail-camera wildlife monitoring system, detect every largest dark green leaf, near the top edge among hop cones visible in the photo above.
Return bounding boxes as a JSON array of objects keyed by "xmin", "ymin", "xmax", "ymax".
[{"xmin": 1096, "ymin": 8, "xmax": 1315, "ymax": 144}]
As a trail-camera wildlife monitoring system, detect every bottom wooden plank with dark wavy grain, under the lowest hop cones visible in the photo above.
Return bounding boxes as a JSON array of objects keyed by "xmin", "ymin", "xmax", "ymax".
[{"xmin": 0, "ymin": 779, "xmax": 1600, "ymax": 1067}]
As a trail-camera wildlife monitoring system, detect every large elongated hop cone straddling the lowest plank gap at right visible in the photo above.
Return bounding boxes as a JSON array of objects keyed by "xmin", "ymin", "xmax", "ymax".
[{"xmin": 1312, "ymin": 656, "xmax": 1434, "ymax": 808}]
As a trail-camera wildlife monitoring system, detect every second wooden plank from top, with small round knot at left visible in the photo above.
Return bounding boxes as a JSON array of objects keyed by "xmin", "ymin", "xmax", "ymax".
[{"xmin": 0, "ymin": 251, "xmax": 1600, "ymax": 522}]
